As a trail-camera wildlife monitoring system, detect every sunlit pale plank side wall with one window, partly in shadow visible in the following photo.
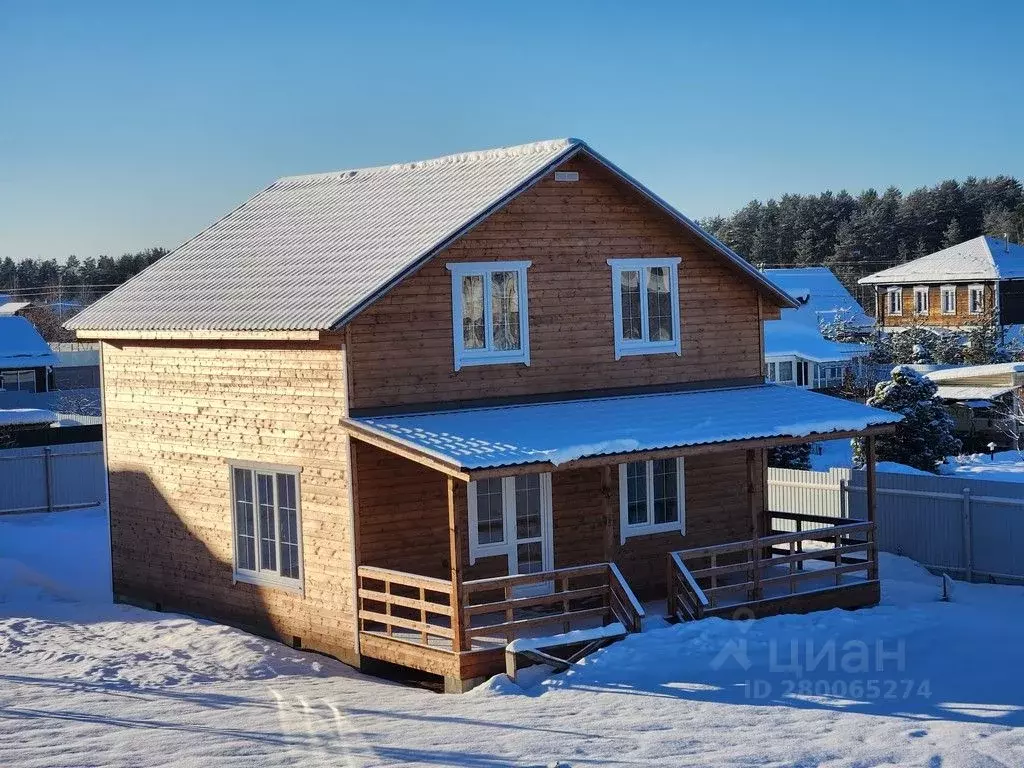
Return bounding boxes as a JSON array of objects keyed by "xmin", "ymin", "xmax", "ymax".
[{"xmin": 102, "ymin": 341, "xmax": 355, "ymax": 662}]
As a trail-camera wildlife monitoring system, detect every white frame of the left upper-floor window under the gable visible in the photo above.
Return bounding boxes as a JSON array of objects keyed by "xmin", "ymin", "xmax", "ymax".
[{"xmin": 445, "ymin": 261, "xmax": 531, "ymax": 371}]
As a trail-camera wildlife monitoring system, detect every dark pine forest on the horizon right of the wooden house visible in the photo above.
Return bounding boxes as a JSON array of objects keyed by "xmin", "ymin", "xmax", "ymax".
[{"xmin": 700, "ymin": 176, "xmax": 1024, "ymax": 303}]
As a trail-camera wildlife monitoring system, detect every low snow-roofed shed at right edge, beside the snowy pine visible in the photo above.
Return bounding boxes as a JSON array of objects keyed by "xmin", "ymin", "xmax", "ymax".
[{"xmin": 925, "ymin": 362, "xmax": 1024, "ymax": 451}]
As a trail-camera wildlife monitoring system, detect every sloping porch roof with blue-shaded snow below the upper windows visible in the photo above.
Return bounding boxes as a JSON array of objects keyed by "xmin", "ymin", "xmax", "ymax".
[{"xmin": 342, "ymin": 384, "xmax": 903, "ymax": 479}]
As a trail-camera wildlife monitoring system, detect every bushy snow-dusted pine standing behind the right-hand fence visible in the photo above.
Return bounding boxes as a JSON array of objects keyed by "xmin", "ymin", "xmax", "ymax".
[{"xmin": 853, "ymin": 366, "xmax": 961, "ymax": 472}]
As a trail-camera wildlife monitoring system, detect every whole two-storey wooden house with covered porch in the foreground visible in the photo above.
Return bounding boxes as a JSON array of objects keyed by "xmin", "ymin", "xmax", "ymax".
[{"xmin": 68, "ymin": 139, "xmax": 900, "ymax": 689}]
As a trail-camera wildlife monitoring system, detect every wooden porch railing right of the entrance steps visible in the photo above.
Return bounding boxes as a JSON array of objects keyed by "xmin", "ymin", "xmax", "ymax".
[{"xmin": 668, "ymin": 512, "xmax": 878, "ymax": 621}]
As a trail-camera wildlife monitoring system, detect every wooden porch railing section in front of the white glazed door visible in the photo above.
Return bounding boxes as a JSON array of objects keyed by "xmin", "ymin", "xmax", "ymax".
[{"xmin": 463, "ymin": 563, "xmax": 645, "ymax": 641}]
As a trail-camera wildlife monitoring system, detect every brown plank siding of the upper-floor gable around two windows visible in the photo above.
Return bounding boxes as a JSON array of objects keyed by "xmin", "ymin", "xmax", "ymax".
[{"xmin": 348, "ymin": 152, "xmax": 777, "ymax": 409}]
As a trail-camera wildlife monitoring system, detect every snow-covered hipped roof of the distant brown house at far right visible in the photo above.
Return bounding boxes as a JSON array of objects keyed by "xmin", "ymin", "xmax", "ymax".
[{"xmin": 859, "ymin": 234, "xmax": 1024, "ymax": 285}]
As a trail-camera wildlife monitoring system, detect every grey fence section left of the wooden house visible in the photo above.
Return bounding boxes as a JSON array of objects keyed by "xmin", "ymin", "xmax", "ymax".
[{"xmin": 0, "ymin": 442, "xmax": 106, "ymax": 514}]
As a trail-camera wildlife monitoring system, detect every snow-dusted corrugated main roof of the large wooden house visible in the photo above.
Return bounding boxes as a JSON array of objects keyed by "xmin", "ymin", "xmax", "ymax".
[{"xmin": 67, "ymin": 139, "xmax": 791, "ymax": 331}]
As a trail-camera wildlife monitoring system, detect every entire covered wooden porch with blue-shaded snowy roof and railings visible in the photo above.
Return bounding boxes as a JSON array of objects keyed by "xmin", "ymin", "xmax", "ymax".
[{"xmin": 346, "ymin": 387, "xmax": 898, "ymax": 690}]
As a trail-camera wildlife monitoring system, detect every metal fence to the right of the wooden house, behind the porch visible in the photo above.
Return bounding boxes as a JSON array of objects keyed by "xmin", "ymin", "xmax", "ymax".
[{"xmin": 768, "ymin": 468, "xmax": 1024, "ymax": 583}]
